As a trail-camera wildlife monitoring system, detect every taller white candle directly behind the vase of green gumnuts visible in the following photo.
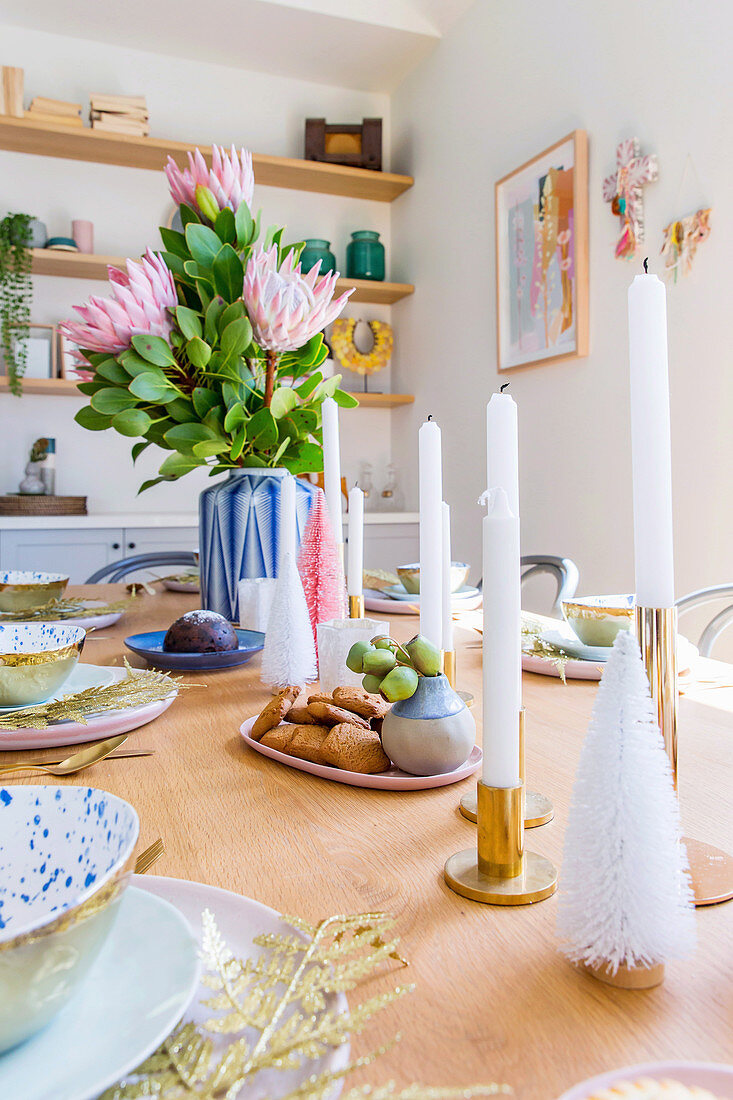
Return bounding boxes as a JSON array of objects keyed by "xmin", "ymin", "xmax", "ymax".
[{"xmin": 418, "ymin": 420, "xmax": 442, "ymax": 648}]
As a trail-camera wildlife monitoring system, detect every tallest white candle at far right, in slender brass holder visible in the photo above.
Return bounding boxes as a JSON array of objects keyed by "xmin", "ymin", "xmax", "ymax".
[{"xmin": 628, "ymin": 275, "xmax": 675, "ymax": 607}]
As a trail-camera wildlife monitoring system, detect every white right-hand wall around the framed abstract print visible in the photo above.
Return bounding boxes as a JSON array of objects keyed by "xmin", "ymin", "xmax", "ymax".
[{"xmin": 392, "ymin": 0, "xmax": 733, "ymax": 629}]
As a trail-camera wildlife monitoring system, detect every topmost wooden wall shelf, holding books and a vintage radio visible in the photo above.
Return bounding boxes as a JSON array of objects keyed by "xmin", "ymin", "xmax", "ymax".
[{"xmin": 0, "ymin": 116, "xmax": 414, "ymax": 202}]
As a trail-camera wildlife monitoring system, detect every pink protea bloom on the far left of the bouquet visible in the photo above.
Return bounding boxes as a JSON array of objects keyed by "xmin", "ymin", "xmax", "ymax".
[{"xmin": 61, "ymin": 249, "xmax": 178, "ymax": 362}]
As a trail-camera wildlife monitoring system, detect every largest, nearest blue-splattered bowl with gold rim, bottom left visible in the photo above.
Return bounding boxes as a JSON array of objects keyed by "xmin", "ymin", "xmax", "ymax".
[{"xmin": 0, "ymin": 785, "xmax": 140, "ymax": 1053}]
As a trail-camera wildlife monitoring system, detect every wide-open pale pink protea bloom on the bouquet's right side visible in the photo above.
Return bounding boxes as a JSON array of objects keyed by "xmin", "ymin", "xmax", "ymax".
[{"xmin": 242, "ymin": 245, "xmax": 353, "ymax": 352}]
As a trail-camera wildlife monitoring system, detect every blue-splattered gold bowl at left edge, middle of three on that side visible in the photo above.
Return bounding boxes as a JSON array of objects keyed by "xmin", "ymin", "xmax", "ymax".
[{"xmin": 0, "ymin": 623, "xmax": 86, "ymax": 707}]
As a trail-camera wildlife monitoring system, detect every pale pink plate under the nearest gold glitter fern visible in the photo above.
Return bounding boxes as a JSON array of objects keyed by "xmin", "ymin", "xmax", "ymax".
[{"xmin": 134, "ymin": 875, "xmax": 349, "ymax": 1100}]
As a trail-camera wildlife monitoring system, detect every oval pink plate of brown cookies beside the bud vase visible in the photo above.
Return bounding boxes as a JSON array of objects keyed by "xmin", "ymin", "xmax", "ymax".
[{"xmin": 240, "ymin": 688, "xmax": 481, "ymax": 791}]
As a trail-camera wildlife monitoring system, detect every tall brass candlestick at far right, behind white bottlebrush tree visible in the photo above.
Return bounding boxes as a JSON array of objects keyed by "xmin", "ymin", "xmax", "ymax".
[{"xmin": 636, "ymin": 606, "xmax": 733, "ymax": 905}]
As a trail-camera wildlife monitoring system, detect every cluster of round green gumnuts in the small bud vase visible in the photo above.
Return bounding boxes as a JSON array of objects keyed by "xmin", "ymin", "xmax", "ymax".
[{"xmin": 347, "ymin": 634, "xmax": 441, "ymax": 703}]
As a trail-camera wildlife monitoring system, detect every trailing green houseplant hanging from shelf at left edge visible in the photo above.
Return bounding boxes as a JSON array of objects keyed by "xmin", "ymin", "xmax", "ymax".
[{"xmin": 0, "ymin": 213, "xmax": 33, "ymax": 396}]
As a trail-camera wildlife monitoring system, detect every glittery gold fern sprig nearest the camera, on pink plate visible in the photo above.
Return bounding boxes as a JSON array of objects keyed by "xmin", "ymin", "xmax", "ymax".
[{"xmin": 100, "ymin": 910, "xmax": 512, "ymax": 1100}]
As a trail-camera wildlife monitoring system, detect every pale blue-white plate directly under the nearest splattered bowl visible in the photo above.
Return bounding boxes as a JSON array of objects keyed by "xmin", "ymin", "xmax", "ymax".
[{"xmin": 0, "ymin": 887, "xmax": 199, "ymax": 1100}]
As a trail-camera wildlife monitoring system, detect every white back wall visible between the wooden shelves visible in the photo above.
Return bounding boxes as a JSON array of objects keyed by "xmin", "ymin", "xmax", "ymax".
[{"xmin": 0, "ymin": 26, "xmax": 391, "ymax": 512}]
